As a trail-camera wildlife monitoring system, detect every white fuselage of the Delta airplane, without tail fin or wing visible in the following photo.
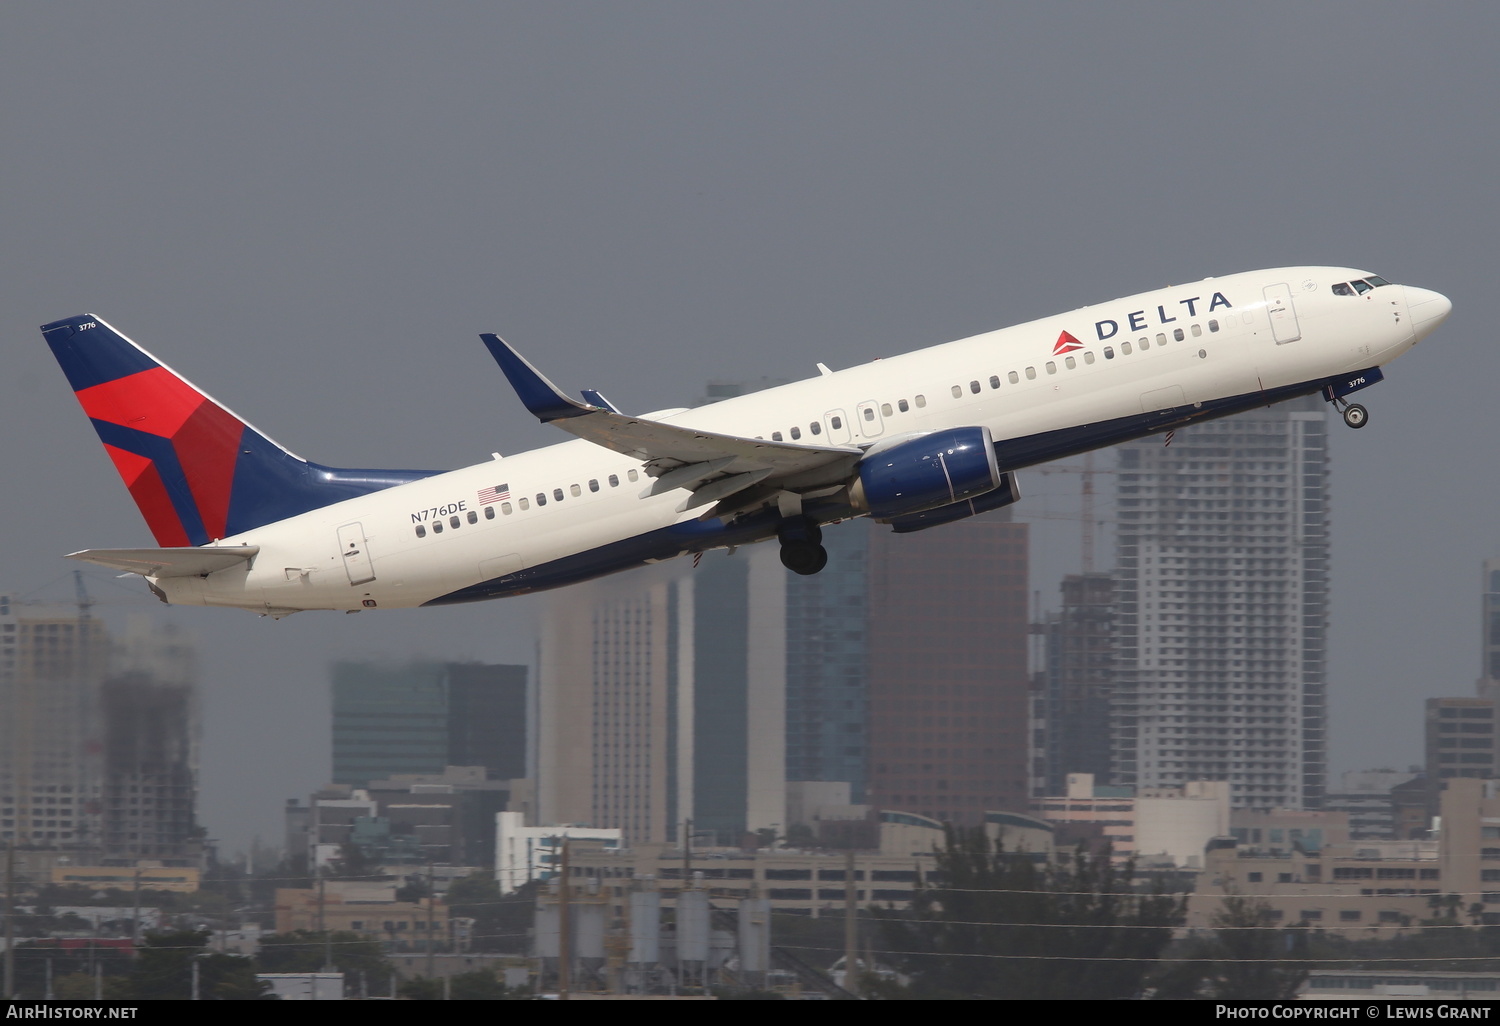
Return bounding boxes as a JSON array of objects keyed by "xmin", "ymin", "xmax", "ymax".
[{"xmin": 155, "ymin": 267, "xmax": 1434, "ymax": 615}]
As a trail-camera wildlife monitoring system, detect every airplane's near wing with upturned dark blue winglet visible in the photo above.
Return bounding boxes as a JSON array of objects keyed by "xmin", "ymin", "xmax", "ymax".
[{"xmin": 480, "ymin": 333, "xmax": 864, "ymax": 494}]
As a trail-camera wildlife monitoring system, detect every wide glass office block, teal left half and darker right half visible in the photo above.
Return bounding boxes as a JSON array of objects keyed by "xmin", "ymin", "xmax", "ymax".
[{"xmin": 333, "ymin": 660, "xmax": 527, "ymax": 788}]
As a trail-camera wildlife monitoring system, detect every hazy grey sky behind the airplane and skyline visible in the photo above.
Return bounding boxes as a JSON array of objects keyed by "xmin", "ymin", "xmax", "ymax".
[{"xmin": 0, "ymin": 2, "xmax": 1500, "ymax": 846}]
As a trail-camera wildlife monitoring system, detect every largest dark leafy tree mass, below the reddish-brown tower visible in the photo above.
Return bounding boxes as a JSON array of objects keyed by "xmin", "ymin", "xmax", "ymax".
[{"xmin": 882, "ymin": 828, "xmax": 1185, "ymax": 999}]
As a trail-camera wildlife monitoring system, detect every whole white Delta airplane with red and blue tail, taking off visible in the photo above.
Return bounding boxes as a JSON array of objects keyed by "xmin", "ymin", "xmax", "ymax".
[{"xmin": 42, "ymin": 267, "xmax": 1452, "ymax": 617}]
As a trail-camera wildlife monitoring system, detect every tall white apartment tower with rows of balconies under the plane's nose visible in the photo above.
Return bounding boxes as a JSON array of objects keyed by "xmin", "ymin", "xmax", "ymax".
[{"xmin": 1112, "ymin": 398, "xmax": 1329, "ymax": 809}]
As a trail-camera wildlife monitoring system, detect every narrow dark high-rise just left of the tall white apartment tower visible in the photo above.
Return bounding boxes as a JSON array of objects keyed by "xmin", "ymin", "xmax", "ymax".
[{"xmin": 1041, "ymin": 573, "xmax": 1115, "ymax": 795}]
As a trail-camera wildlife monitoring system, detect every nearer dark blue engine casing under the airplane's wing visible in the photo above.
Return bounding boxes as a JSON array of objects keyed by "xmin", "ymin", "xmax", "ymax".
[{"xmin": 849, "ymin": 428, "xmax": 1001, "ymax": 521}]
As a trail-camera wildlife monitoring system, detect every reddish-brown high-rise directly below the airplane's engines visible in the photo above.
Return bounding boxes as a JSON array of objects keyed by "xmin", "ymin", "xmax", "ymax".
[{"xmin": 867, "ymin": 513, "xmax": 1031, "ymax": 827}]
